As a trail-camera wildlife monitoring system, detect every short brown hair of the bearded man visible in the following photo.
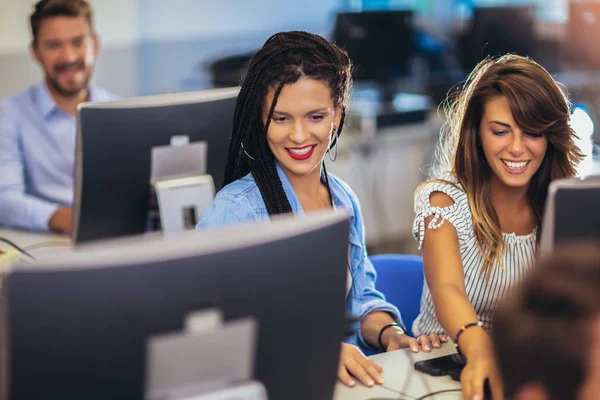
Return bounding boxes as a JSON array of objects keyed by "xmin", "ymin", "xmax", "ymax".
[{"xmin": 29, "ymin": 0, "xmax": 93, "ymax": 43}]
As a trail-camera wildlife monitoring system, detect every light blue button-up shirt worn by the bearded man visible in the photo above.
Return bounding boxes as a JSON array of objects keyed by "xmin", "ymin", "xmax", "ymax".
[{"xmin": 0, "ymin": 83, "xmax": 116, "ymax": 231}]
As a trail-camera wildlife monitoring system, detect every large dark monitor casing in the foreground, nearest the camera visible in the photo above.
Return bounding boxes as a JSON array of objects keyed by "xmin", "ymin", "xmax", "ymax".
[{"xmin": 0, "ymin": 210, "xmax": 349, "ymax": 400}]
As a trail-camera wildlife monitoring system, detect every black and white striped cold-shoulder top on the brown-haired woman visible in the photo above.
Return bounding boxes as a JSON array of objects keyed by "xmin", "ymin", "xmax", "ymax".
[{"xmin": 412, "ymin": 179, "xmax": 537, "ymax": 336}]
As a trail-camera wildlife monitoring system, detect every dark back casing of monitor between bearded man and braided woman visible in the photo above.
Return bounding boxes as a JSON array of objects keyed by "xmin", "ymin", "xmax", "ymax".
[{"xmin": 73, "ymin": 88, "xmax": 239, "ymax": 244}]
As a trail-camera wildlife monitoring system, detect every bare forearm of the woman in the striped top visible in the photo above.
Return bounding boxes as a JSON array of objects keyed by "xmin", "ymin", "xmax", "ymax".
[{"xmin": 430, "ymin": 284, "xmax": 491, "ymax": 359}]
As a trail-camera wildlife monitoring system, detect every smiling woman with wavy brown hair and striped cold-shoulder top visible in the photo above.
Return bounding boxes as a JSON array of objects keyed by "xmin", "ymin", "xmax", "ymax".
[{"xmin": 413, "ymin": 55, "xmax": 582, "ymax": 399}]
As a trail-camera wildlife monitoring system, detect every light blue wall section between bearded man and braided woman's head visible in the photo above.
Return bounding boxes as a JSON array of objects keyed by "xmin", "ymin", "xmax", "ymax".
[{"xmin": 138, "ymin": 0, "xmax": 344, "ymax": 94}]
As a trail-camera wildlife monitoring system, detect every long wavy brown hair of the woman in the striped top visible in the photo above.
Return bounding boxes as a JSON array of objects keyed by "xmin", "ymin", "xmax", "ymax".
[{"xmin": 431, "ymin": 54, "xmax": 583, "ymax": 276}]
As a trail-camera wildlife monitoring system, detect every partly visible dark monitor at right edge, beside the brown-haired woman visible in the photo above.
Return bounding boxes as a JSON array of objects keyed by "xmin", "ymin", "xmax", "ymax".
[{"xmin": 540, "ymin": 176, "xmax": 600, "ymax": 256}]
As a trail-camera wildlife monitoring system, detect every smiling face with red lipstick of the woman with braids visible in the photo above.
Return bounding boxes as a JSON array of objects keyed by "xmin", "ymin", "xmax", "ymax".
[{"xmin": 263, "ymin": 77, "xmax": 339, "ymax": 178}]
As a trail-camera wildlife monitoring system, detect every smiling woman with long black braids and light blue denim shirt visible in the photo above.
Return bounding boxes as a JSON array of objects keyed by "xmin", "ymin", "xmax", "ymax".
[{"xmin": 198, "ymin": 32, "xmax": 446, "ymax": 386}]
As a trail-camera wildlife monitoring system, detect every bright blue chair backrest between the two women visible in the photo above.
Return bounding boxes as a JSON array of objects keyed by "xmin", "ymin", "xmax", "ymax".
[{"xmin": 369, "ymin": 254, "xmax": 424, "ymax": 335}]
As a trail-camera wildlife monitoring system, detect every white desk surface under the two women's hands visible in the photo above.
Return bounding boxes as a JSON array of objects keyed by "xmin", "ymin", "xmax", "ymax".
[{"xmin": 333, "ymin": 343, "xmax": 462, "ymax": 400}]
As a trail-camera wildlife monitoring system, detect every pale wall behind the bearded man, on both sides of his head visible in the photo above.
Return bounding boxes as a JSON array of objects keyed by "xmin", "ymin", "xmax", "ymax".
[{"xmin": 0, "ymin": 0, "xmax": 344, "ymax": 99}]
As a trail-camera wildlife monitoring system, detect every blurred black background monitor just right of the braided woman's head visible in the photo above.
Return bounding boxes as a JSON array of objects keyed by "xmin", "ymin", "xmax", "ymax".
[{"xmin": 333, "ymin": 10, "xmax": 416, "ymax": 101}]
